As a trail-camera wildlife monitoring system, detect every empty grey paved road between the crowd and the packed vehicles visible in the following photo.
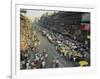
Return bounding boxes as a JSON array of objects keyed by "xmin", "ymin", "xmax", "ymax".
[{"xmin": 32, "ymin": 26, "xmax": 73, "ymax": 68}]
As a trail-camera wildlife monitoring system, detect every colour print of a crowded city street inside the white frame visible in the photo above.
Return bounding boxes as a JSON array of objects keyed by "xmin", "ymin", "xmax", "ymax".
[{"xmin": 20, "ymin": 9, "xmax": 90, "ymax": 70}]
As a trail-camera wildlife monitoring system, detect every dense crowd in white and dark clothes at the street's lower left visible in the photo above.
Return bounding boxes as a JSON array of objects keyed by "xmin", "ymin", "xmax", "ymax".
[{"xmin": 20, "ymin": 49, "xmax": 48, "ymax": 69}]
